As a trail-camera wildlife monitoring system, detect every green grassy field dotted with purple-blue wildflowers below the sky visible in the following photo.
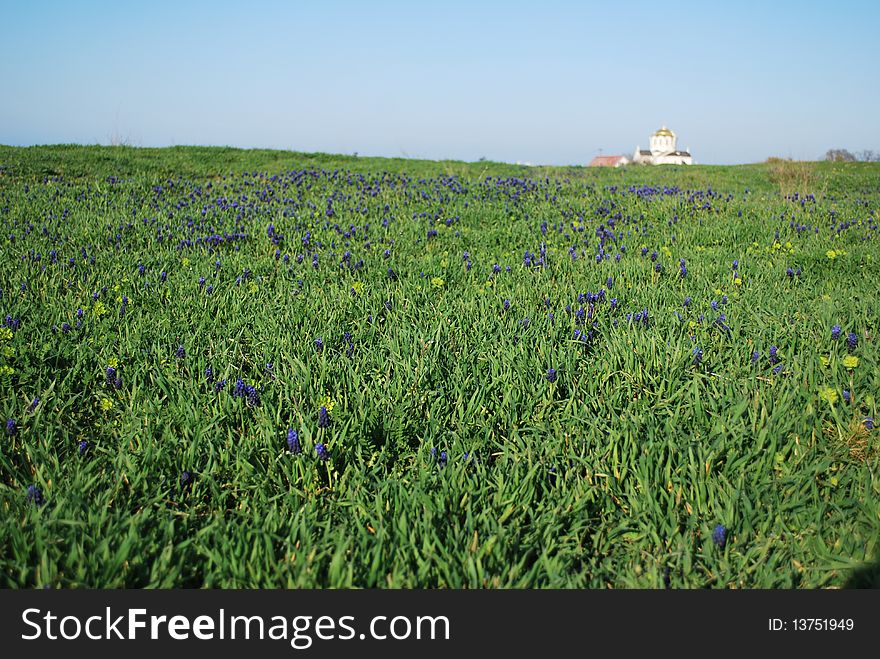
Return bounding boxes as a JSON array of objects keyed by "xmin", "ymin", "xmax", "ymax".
[{"xmin": 0, "ymin": 146, "xmax": 880, "ymax": 588}]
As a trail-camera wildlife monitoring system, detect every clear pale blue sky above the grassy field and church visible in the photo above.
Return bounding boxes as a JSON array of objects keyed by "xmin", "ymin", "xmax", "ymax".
[{"xmin": 0, "ymin": 0, "xmax": 880, "ymax": 164}]
